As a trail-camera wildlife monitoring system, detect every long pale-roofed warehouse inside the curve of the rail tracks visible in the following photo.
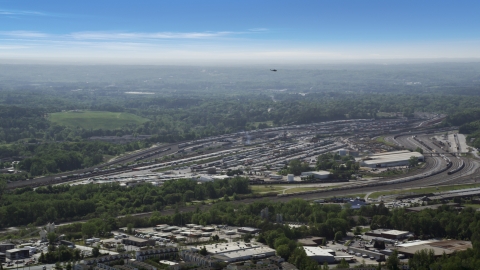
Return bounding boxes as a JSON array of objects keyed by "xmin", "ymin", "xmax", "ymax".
[{"xmin": 360, "ymin": 150, "xmax": 425, "ymax": 168}]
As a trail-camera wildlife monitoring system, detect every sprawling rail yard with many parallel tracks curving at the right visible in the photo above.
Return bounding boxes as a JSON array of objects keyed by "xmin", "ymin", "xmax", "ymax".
[{"xmin": 4, "ymin": 113, "xmax": 480, "ymax": 210}]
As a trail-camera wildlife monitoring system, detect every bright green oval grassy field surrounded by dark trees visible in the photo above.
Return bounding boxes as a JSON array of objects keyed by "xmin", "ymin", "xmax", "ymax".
[{"xmin": 49, "ymin": 111, "xmax": 148, "ymax": 130}]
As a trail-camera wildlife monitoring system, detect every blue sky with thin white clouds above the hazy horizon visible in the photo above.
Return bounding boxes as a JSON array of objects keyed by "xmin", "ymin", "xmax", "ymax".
[{"xmin": 0, "ymin": 0, "xmax": 480, "ymax": 64}]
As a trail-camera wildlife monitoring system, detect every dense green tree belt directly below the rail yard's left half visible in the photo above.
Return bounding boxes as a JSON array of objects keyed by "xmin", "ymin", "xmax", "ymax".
[{"xmin": 0, "ymin": 177, "xmax": 251, "ymax": 227}]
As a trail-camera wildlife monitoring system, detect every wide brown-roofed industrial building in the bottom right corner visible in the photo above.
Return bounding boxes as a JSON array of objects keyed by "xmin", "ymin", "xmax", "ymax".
[{"xmin": 397, "ymin": 240, "xmax": 472, "ymax": 258}]
